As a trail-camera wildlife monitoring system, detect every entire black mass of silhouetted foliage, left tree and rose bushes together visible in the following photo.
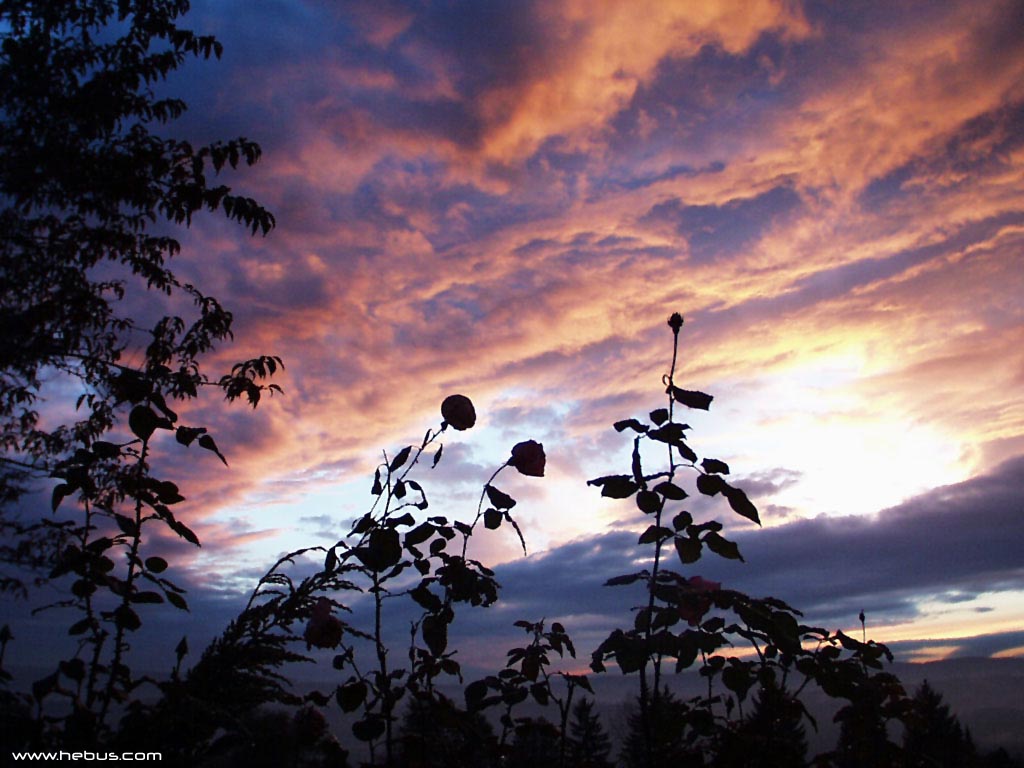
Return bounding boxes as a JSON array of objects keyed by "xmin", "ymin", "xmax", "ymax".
[{"xmin": 0, "ymin": 0, "xmax": 1009, "ymax": 768}]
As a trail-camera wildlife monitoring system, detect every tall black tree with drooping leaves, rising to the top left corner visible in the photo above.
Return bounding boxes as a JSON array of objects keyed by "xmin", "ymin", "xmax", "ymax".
[{"xmin": 0, "ymin": 0, "xmax": 274, "ymax": 589}]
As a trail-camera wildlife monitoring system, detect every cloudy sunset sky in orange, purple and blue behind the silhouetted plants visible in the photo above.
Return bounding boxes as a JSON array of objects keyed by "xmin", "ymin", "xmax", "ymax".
[{"xmin": 6, "ymin": 0, "xmax": 1024, "ymax": 684}]
